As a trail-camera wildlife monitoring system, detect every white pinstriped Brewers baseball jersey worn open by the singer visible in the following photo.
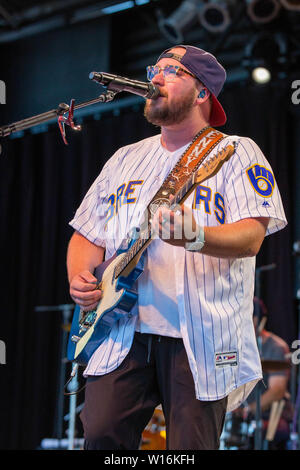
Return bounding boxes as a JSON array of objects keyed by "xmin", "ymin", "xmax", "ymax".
[{"xmin": 70, "ymin": 135, "xmax": 287, "ymax": 411}]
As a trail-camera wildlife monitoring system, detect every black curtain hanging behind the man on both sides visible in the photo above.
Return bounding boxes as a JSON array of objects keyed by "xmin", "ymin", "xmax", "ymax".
[{"xmin": 0, "ymin": 76, "xmax": 300, "ymax": 449}]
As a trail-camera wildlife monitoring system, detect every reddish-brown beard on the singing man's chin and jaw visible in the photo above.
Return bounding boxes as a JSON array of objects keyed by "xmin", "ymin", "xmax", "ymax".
[{"xmin": 144, "ymin": 89, "xmax": 195, "ymax": 126}]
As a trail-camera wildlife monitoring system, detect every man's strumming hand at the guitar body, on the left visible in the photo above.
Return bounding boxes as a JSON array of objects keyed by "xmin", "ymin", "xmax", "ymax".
[{"xmin": 70, "ymin": 271, "xmax": 102, "ymax": 311}]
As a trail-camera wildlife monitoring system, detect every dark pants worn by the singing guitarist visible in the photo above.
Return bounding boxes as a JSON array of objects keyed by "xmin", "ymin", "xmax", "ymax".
[{"xmin": 81, "ymin": 333, "xmax": 227, "ymax": 450}]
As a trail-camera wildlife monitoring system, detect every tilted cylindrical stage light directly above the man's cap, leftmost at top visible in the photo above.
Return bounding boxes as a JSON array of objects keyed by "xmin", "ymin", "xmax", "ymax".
[{"xmin": 158, "ymin": 0, "xmax": 201, "ymax": 44}]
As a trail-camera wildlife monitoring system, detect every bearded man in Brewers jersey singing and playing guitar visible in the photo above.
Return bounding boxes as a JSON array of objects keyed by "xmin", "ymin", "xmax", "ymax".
[{"xmin": 67, "ymin": 45, "xmax": 286, "ymax": 450}]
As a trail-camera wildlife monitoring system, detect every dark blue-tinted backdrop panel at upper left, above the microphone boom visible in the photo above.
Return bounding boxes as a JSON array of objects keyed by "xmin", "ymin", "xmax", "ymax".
[{"xmin": 0, "ymin": 17, "xmax": 110, "ymax": 125}]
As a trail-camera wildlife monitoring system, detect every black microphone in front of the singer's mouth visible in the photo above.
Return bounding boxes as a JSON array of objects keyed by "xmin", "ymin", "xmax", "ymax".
[{"xmin": 89, "ymin": 72, "xmax": 160, "ymax": 99}]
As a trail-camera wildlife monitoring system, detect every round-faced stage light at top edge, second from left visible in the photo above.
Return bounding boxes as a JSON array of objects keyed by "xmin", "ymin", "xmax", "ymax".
[{"xmin": 198, "ymin": 1, "xmax": 231, "ymax": 33}]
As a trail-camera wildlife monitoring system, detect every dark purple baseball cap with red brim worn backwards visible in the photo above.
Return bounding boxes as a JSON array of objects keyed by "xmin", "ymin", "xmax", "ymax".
[{"xmin": 157, "ymin": 45, "xmax": 227, "ymax": 126}]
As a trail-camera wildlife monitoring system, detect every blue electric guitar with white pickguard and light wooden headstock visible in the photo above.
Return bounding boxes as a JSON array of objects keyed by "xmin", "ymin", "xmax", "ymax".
[{"xmin": 67, "ymin": 143, "xmax": 235, "ymax": 365}]
